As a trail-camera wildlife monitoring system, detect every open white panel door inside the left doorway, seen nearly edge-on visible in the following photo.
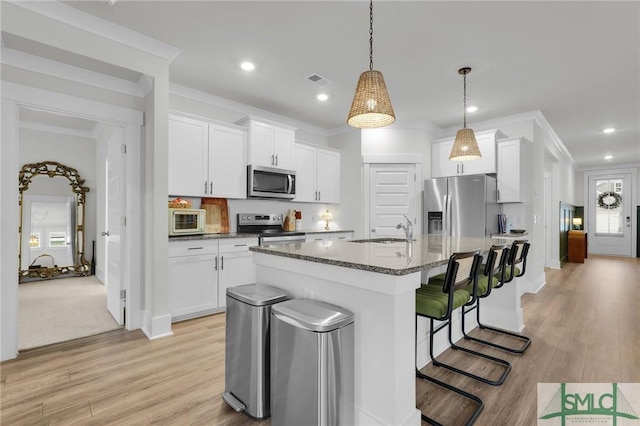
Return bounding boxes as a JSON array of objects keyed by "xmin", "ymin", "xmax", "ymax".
[{"xmin": 103, "ymin": 131, "xmax": 125, "ymax": 325}]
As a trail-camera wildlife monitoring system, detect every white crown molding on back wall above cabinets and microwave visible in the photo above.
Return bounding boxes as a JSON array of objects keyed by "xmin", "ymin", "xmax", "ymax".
[{"xmin": 169, "ymin": 83, "xmax": 330, "ymax": 137}]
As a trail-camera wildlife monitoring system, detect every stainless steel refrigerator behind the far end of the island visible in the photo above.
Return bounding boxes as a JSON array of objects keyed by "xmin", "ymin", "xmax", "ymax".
[{"xmin": 422, "ymin": 175, "xmax": 502, "ymax": 237}]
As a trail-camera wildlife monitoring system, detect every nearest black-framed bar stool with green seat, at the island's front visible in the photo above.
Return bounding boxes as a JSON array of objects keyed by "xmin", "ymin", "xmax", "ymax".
[{"xmin": 416, "ymin": 250, "xmax": 484, "ymax": 425}]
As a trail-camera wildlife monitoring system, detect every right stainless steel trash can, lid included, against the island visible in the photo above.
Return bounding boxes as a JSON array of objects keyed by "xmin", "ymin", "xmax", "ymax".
[{"xmin": 271, "ymin": 299, "xmax": 354, "ymax": 426}]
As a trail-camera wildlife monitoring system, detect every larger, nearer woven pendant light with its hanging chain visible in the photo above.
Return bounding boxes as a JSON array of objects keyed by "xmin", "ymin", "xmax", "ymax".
[{"xmin": 347, "ymin": 0, "xmax": 396, "ymax": 129}]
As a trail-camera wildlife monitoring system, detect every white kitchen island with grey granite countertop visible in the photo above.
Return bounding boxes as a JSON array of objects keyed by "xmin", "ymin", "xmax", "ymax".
[{"xmin": 251, "ymin": 235, "xmax": 519, "ymax": 425}]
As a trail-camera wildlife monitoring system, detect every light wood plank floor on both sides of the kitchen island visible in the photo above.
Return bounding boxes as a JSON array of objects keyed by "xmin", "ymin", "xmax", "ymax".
[{"xmin": 0, "ymin": 256, "xmax": 640, "ymax": 426}]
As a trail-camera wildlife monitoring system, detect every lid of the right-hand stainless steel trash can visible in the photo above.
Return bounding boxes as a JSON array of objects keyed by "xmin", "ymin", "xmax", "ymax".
[{"xmin": 271, "ymin": 299, "xmax": 353, "ymax": 333}]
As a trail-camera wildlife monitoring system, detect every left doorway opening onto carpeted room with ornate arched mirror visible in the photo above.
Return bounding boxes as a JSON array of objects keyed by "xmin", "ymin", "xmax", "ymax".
[{"xmin": 17, "ymin": 107, "xmax": 126, "ymax": 349}]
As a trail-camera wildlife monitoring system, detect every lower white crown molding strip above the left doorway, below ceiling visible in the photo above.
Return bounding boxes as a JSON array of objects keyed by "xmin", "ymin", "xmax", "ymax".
[{"xmin": 2, "ymin": 47, "xmax": 150, "ymax": 98}]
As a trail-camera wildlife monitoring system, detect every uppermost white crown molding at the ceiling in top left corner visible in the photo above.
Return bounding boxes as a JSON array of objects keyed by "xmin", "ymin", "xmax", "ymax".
[{"xmin": 3, "ymin": 0, "xmax": 180, "ymax": 62}]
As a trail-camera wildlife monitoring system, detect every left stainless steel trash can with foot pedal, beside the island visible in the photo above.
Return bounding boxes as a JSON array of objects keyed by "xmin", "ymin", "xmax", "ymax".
[{"xmin": 222, "ymin": 284, "xmax": 289, "ymax": 419}]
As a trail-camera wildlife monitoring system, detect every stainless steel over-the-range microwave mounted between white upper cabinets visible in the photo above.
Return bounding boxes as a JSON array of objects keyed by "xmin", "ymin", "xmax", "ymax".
[{"xmin": 247, "ymin": 165, "xmax": 296, "ymax": 199}]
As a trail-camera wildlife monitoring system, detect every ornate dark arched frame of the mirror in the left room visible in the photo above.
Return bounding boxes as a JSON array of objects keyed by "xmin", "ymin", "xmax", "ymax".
[{"xmin": 18, "ymin": 161, "xmax": 90, "ymax": 281}]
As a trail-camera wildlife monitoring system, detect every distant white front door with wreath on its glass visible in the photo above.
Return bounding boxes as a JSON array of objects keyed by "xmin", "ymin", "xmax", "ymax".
[{"xmin": 587, "ymin": 173, "xmax": 633, "ymax": 256}]
